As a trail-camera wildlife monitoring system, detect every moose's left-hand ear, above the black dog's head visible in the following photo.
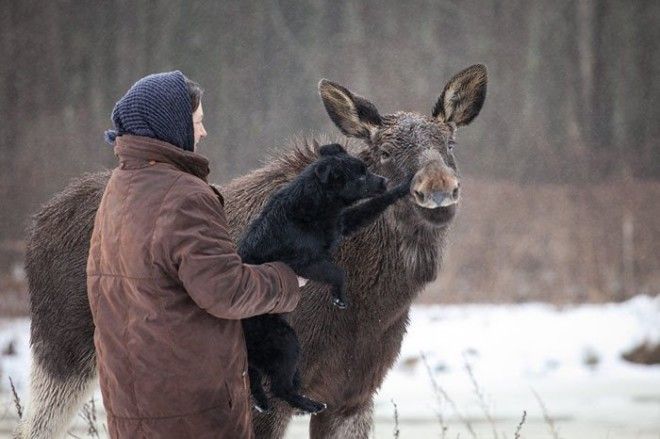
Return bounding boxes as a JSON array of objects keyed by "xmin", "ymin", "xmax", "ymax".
[{"xmin": 319, "ymin": 79, "xmax": 382, "ymax": 138}]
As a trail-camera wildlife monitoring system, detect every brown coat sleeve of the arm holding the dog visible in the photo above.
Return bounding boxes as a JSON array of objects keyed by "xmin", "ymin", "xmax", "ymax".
[{"xmin": 152, "ymin": 192, "xmax": 300, "ymax": 319}]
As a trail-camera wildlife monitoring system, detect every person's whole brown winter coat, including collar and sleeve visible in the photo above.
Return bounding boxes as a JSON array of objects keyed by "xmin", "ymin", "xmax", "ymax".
[{"xmin": 87, "ymin": 135, "xmax": 299, "ymax": 439}]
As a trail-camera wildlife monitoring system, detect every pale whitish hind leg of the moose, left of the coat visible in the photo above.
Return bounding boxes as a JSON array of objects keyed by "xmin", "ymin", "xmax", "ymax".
[{"xmin": 14, "ymin": 356, "xmax": 97, "ymax": 439}]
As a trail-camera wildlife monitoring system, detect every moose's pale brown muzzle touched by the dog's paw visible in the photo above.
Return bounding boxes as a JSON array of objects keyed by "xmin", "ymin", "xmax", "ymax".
[{"xmin": 411, "ymin": 160, "xmax": 460, "ymax": 209}]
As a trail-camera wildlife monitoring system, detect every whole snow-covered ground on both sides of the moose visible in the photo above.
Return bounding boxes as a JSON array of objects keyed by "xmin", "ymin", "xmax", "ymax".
[{"xmin": 0, "ymin": 296, "xmax": 660, "ymax": 439}]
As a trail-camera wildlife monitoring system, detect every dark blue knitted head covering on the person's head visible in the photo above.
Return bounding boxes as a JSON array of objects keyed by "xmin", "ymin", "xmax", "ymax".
[{"xmin": 105, "ymin": 70, "xmax": 195, "ymax": 151}]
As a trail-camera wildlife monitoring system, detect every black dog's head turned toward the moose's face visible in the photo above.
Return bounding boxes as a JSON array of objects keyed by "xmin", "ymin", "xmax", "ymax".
[{"xmin": 314, "ymin": 143, "xmax": 387, "ymax": 204}]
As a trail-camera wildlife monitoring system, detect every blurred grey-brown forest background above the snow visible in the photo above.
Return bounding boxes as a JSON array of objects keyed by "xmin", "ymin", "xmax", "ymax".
[{"xmin": 0, "ymin": 0, "xmax": 660, "ymax": 313}]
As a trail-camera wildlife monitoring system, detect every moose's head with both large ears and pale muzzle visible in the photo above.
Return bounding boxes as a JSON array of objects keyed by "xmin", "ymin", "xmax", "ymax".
[{"xmin": 319, "ymin": 64, "xmax": 487, "ymax": 230}]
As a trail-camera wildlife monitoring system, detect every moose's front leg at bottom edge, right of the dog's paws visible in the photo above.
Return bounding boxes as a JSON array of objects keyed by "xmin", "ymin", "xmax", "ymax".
[{"xmin": 309, "ymin": 401, "xmax": 373, "ymax": 439}]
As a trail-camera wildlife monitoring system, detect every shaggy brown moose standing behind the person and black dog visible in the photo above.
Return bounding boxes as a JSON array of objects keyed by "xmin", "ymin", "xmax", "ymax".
[{"xmin": 15, "ymin": 64, "xmax": 487, "ymax": 439}]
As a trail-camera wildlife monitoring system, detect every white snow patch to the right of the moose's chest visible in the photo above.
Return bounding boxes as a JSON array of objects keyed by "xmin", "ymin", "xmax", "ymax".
[{"xmin": 376, "ymin": 296, "xmax": 660, "ymax": 437}]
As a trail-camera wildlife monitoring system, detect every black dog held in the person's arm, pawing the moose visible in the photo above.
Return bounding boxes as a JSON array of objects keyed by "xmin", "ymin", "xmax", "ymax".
[{"xmin": 238, "ymin": 144, "xmax": 410, "ymax": 413}]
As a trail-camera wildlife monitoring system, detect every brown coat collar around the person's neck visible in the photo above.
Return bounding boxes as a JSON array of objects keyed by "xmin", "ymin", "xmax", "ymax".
[{"xmin": 115, "ymin": 134, "xmax": 209, "ymax": 181}]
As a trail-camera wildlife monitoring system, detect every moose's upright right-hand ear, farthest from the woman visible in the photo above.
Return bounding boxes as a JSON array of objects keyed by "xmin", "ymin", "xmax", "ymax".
[{"xmin": 433, "ymin": 64, "xmax": 488, "ymax": 126}]
